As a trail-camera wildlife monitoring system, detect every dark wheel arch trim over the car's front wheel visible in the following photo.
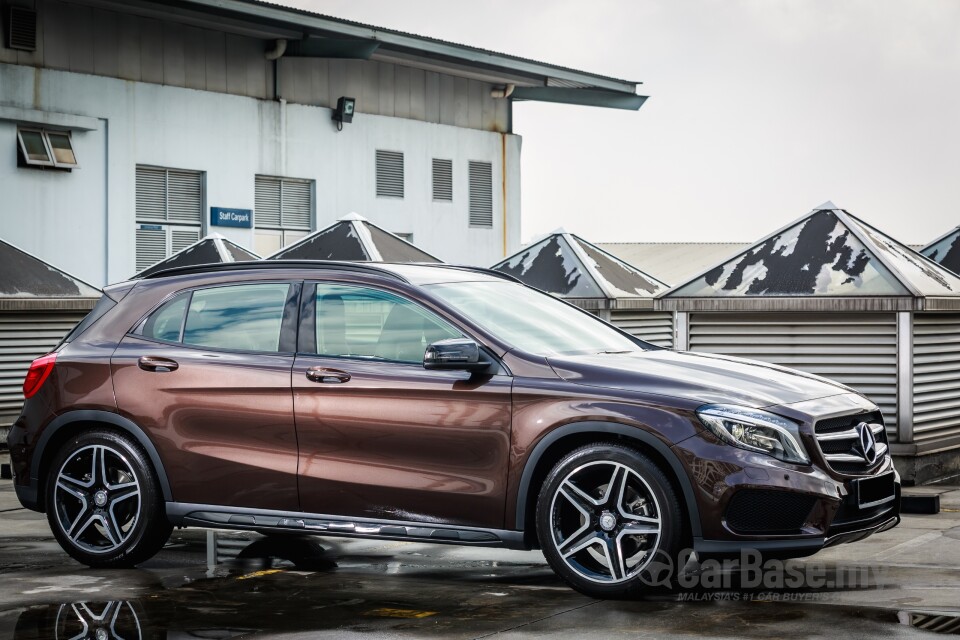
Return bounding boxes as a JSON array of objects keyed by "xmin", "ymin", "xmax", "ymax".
[{"xmin": 515, "ymin": 421, "xmax": 702, "ymax": 537}]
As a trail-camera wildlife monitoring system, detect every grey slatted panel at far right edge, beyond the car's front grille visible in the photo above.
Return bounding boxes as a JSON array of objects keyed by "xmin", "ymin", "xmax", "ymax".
[{"xmin": 913, "ymin": 313, "xmax": 960, "ymax": 440}]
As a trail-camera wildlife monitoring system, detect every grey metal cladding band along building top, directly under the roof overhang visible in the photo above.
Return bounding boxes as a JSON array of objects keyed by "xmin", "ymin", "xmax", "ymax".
[{"xmin": 0, "ymin": 0, "xmax": 510, "ymax": 132}]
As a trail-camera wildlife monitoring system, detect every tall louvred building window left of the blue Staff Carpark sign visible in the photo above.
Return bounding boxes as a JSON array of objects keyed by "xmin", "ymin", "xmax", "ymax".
[{"xmin": 136, "ymin": 165, "xmax": 203, "ymax": 272}]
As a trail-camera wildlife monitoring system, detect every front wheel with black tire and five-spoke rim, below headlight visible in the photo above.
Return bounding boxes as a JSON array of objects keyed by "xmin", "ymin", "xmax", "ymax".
[{"xmin": 536, "ymin": 443, "xmax": 683, "ymax": 598}]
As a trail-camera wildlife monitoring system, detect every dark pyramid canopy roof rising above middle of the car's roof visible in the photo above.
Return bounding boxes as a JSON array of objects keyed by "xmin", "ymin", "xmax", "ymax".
[{"xmin": 267, "ymin": 213, "xmax": 442, "ymax": 262}]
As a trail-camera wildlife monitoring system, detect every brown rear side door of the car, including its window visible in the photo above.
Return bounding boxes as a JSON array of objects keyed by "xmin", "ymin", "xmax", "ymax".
[{"xmin": 111, "ymin": 282, "xmax": 300, "ymax": 511}]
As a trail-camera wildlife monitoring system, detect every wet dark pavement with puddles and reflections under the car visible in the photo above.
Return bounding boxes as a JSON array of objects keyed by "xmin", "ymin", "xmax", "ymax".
[{"xmin": 0, "ymin": 450, "xmax": 960, "ymax": 640}]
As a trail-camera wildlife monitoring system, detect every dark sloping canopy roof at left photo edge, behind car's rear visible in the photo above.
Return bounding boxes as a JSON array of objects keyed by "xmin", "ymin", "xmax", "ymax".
[{"xmin": 0, "ymin": 240, "xmax": 100, "ymax": 310}]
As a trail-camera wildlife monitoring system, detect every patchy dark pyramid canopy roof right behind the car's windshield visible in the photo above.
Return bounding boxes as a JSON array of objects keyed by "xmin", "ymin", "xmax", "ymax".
[{"xmin": 492, "ymin": 229, "xmax": 667, "ymax": 300}]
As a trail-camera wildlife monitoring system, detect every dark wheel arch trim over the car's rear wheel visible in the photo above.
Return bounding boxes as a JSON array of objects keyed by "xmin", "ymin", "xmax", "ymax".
[{"xmin": 30, "ymin": 409, "xmax": 173, "ymax": 509}]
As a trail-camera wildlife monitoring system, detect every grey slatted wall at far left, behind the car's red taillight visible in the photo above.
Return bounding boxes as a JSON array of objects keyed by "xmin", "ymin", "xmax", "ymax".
[{"xmin": 0, "ymin": 311, "xmax": 87, "ymax": 426}]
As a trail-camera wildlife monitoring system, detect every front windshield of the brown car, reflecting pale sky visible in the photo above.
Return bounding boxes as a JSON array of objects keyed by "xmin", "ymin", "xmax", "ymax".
[{"xmin": 424, "ymin": 282, "xmax": 643, "ymax": 356}]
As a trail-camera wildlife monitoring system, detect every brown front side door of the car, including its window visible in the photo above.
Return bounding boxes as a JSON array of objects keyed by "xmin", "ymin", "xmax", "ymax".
[{"xmin": 293, "ymin": 282, "xmax": 512, "ymax": 528}]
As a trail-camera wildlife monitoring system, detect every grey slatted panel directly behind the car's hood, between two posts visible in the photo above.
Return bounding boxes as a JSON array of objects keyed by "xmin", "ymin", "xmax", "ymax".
[{"xmin": 690, "ymin": 313, "xmax": 897, "ymax": 438}]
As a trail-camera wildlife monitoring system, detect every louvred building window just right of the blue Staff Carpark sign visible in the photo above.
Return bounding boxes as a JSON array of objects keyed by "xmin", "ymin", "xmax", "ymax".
[{"xmin": 253, "ymin": 176, "xmax": 313, "ymax": 257}]
